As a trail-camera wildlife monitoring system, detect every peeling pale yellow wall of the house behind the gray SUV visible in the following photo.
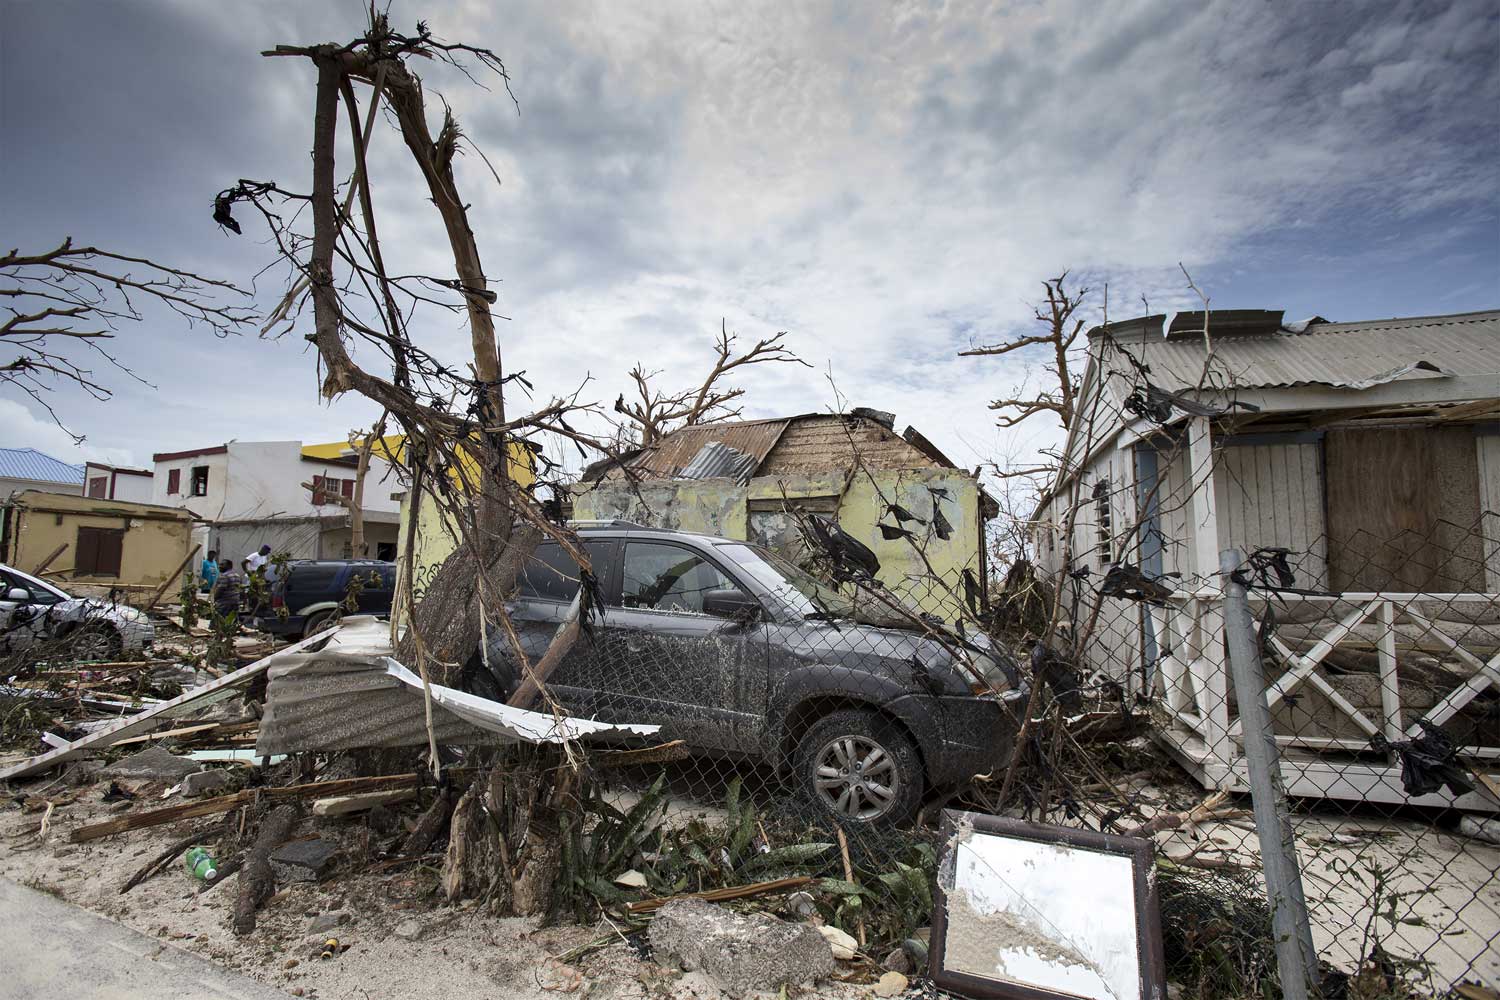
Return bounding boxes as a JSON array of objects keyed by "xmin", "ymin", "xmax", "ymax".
[{"xmin": 573, "ymin": 469, "xmax": 984, "ymax": 621}]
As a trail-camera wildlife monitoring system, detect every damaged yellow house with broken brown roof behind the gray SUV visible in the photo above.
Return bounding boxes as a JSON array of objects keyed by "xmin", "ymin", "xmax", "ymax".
[{"xmin": 573, "ymin": 408, "xmax": 998, "ymax": 619}]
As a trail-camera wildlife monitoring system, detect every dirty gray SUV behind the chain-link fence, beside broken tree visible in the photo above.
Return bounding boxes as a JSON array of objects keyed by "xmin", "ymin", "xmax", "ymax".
[{"xmin": 465, "ymin": 522, "xmax": 1023, "ymax": 825}]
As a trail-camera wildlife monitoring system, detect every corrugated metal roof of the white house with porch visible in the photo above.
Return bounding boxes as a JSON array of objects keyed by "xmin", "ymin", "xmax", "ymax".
[{"xmin": 1089, "ymin": 310, "xmax": 1500, "ymax": 393}]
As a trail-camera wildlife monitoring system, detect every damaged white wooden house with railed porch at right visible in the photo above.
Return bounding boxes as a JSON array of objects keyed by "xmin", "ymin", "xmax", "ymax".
[{"xmin": 1035, "ymin": 310, "xmax": 1500, "ymax": 808}]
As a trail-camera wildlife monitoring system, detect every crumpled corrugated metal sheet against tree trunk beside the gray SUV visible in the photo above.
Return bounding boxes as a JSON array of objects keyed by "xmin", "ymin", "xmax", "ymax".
[{"xmin": 255, "ymin": 616, "xmax": 659, "ymax": 754}]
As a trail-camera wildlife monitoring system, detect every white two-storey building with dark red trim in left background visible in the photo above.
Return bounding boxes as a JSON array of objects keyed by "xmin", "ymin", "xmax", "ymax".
[{"xmin": 152, "ymin": 441, "xmax": 401, "ymax": 562}]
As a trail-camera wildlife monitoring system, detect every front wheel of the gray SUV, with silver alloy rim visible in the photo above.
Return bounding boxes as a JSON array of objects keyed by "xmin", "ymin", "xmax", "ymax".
[{"xmin": 795, "ymin": 709, "xmax": 923, "ymax": 828}]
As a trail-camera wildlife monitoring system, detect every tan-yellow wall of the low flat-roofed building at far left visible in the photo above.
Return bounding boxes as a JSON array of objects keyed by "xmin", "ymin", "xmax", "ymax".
[{"xmin": 6, "ymin": 490, "xmax": 192, "ymax": 592}]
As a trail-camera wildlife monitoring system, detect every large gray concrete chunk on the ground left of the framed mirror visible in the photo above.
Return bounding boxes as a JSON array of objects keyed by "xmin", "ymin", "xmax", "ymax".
[{"xmin": 650, "ymin": 900, "xmax": 834, "ymax": 997}]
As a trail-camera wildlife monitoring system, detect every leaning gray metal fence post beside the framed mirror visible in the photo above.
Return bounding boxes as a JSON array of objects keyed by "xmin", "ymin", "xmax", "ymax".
[{"xmin": 1220, "ymin": 549, "xmax": 1319, "ymax": 1000}]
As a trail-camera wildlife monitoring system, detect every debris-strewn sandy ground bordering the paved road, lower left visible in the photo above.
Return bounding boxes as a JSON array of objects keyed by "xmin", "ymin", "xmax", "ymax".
[{"xmin": 0, "ymin": 783, "xmax": 870, "ymax": 1000}]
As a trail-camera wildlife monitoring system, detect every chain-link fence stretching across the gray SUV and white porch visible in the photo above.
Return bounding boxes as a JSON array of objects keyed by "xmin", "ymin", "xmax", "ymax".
[{"xmin": 498, "ymin": 509, "xmax": 1500, "ymax": 997}]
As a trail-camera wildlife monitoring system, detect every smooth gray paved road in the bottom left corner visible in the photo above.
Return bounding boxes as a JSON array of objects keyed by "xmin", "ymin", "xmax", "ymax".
[{"xmin": 0, "ymin": 879, "xmax": 288, "ymax": 1000}]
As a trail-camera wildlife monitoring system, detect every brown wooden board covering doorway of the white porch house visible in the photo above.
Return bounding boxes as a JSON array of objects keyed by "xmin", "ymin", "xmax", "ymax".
[{"xmin": 1323, "ymin": 427, "xmax": 1485, "ymax": 594}]
